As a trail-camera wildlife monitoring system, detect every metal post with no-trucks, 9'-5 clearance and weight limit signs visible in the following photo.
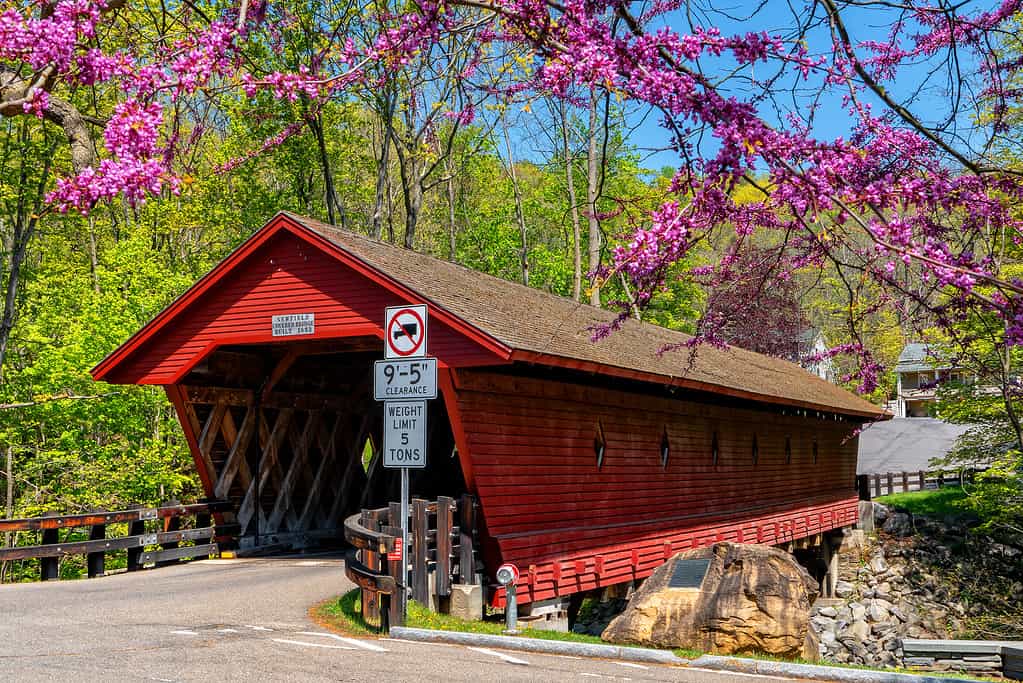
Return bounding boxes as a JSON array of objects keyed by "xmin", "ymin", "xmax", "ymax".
[{"xmin": 382, "ymin": 305, "xmax": 437, "ymax": 616}]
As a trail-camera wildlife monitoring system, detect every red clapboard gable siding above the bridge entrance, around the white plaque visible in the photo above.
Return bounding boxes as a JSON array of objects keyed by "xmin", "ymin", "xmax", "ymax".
[{"xmin": 104, "ymin": 231, "xmax": 501, "ymax": 384}]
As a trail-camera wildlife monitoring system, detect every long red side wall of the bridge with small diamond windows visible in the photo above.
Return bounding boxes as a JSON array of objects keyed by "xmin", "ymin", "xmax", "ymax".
[{"xmin": 456, "ymin": 370, "xmax": 856, "ymax": 601}]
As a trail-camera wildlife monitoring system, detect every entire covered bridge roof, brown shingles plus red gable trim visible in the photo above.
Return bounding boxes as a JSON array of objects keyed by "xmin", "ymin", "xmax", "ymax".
[{"xmin": 92, "ymin": 212, "xmax": 889, "ymax": 419}]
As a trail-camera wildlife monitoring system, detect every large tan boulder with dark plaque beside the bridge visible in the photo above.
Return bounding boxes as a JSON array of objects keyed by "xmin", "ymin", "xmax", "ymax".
[{"xmin": 601, "ymin": 543, "xmax": 819, "ymax": 661}]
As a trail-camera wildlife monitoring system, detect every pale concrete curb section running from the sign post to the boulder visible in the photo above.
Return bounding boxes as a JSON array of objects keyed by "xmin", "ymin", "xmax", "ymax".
[{"xmin": 389, "ymin": 626, "xmax": 687, "ymax": 665}]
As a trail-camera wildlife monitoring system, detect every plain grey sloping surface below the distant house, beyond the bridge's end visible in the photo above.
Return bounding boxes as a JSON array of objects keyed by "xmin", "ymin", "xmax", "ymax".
[{"xmin": 856, "ymin": 417, "xmax": 970, "ymax": 474}]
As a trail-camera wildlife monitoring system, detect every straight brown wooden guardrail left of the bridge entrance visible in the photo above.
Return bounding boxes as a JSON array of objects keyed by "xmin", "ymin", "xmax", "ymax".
[{"xmin": 0, "ymin": 501, "xmax": 237, "ymax": 581}]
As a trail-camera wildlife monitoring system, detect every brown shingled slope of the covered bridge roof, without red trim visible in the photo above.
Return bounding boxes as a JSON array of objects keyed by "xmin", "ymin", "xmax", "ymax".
[{"xmin": 283, "ymin": 213, "xmax": 885, "ymax": 418}]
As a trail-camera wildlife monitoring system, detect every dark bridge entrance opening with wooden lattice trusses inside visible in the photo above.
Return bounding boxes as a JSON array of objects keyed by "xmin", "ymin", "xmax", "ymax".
[{"xmin": 168, "ymin": 335, "xmax": 465, "ymax": 548}]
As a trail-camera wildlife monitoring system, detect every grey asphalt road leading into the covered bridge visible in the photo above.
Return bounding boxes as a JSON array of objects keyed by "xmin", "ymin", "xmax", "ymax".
[{"xmin": 0, "ymin": 556, "xmax": 802, "ymax": 683}]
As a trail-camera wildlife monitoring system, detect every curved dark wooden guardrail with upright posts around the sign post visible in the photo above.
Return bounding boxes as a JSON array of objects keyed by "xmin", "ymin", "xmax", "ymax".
[{"xmin": 345, "ymin": 495, "xmax": 479, "ymax": 631}]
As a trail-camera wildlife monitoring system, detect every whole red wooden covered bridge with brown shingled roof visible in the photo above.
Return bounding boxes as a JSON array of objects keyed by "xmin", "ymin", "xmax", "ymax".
[{"xmin": 93, "ymin": 213, "xmax": 881, "ymax": 602}]
